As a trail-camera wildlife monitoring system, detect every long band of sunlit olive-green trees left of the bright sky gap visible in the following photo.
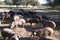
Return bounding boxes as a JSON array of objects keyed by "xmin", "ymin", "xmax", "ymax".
[{"xmin": 5, "ymin": 0, "xmax": 38, "ymax": 6}]
